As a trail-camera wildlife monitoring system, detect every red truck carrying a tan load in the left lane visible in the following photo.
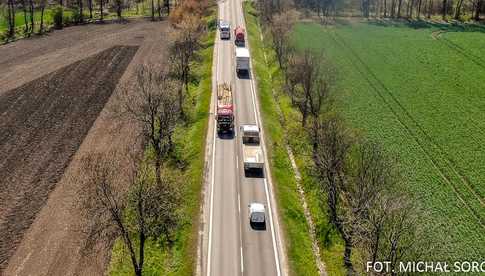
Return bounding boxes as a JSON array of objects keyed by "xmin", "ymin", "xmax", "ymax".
[{"xmin": 216, "ymin": 83, "xmax": 234, "ymax": 133}]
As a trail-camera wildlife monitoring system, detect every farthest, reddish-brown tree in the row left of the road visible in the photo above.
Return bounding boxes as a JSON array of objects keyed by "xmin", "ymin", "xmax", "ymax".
[{"xmin": 170, "ymin": 15, "xmax": 203, "ymax": 118}]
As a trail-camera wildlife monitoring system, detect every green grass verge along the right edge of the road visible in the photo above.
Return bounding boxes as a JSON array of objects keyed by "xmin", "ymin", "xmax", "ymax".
[{"xmin": 244, "ymin": 2, "xmax": 344, "ymax": 275}]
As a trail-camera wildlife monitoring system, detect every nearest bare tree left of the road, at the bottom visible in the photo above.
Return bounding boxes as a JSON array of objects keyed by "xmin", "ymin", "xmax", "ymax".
[{"xmin": 81, "ymin": 152, "xmax": 180, "ymax": 276}]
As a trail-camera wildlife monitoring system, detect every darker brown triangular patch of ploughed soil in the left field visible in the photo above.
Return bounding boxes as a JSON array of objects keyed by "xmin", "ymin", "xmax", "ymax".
[{"xmin": 0, "ymin": 46, "xmax": 138, "ymax": 270}]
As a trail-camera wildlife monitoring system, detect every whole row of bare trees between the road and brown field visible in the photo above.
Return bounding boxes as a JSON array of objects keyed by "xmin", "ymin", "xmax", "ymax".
[{"xmin": 82, "ymin": 2, "xmax": 205, "ymax": 275}]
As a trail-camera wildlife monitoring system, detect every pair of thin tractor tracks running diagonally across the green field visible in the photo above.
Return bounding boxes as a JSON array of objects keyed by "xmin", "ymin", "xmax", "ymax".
[{"xmin": 331, "ymin": 32, "xmax": 485, "ymax": 228}]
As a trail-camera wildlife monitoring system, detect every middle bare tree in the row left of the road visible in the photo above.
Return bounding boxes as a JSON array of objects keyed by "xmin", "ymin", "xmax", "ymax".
[{"xmin": 116, "ymin": 64, "xmax": 180, "ymax": 183}]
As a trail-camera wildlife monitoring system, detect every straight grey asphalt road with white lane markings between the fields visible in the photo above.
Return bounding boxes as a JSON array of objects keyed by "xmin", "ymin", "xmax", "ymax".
[{"xmin": 202, "ymin": 0, "xmax": 286, "ymax": 276}]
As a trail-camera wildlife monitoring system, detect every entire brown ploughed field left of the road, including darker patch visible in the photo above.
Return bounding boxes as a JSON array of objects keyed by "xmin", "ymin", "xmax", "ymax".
[{"xmin": 0, "ymin": 21, "xmax": 169, "ymax": 275}]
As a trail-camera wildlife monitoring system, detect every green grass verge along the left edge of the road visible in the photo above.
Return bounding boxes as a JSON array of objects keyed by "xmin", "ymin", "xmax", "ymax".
[{"xmin": 109, "ymin": 9, "xmax": 216, "ymax": 275}]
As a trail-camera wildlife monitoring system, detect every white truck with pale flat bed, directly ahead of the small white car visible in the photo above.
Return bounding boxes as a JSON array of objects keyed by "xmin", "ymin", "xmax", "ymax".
[{"xmin": 240, "ymin": 125, "xmax": 264, "ymax": 173}]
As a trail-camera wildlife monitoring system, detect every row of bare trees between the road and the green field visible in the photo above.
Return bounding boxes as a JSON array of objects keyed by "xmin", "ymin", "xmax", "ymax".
[{"xmin": 260, "ymin": 3, "xmax": 424, "ymax": 275}]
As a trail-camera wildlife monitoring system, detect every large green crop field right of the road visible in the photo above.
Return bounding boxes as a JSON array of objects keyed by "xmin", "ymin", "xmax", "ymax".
[{"xmin": 293, "ymin": 22, "xmax": 485, "ymax": 260}]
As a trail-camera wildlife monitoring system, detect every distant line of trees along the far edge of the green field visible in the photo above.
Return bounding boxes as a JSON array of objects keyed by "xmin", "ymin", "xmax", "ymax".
[{"xmin": 265, "ymin": 0, "xmax": 485, "ymax": 21}]
